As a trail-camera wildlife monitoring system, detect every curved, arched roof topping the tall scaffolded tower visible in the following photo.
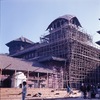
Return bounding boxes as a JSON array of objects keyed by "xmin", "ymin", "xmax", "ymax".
[{"xmin": 46, "ymin": 14, "xmax": 82, "ymax": 30}]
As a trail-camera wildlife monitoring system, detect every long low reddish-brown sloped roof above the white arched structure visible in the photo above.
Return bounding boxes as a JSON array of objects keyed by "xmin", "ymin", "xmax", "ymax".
[{"xmin": 0, "ymin": 54, "xmax": 52, "ymax": 73}]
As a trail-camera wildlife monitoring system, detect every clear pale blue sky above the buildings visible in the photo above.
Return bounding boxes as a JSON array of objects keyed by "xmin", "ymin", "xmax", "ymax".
[{"xmin": 0, "ymin": 0, "xmax": 100, "ymax": 53}]
